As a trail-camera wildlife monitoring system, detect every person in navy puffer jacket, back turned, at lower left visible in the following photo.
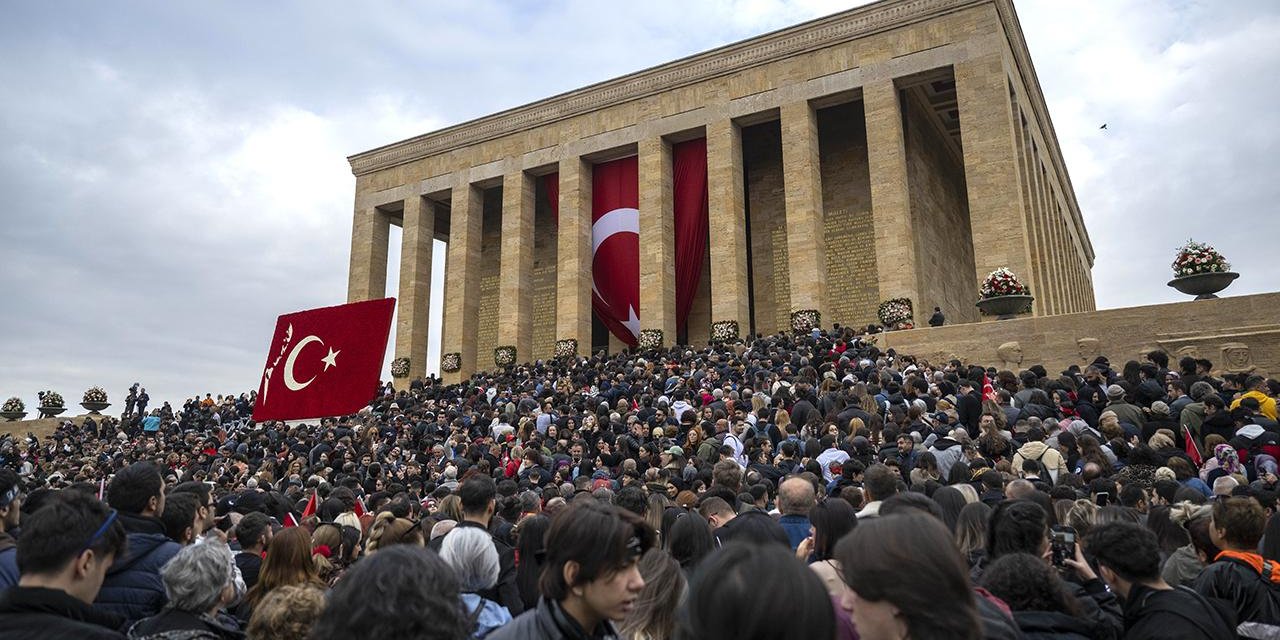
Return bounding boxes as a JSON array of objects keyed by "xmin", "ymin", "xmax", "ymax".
[{"xmin": 93, "ymin": 462, "xmax": 182, "ymax": 623}]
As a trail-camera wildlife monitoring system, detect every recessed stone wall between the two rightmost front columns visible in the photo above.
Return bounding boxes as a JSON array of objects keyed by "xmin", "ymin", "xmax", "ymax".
[{"xmin": 904, "ymin": 87, "xmax": 979, "ymax": 324}]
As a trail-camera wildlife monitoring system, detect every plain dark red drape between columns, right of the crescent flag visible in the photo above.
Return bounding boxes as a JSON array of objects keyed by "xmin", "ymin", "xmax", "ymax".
[{"xmin": 671, "ymin": 138, "xmax": 708, "ymax": 340}]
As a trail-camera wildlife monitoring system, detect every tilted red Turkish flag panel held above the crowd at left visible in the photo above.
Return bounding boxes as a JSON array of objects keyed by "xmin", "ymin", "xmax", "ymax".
[{"xmin": 253, "ymin": 298, "xmax": 396, "ymax": 422}]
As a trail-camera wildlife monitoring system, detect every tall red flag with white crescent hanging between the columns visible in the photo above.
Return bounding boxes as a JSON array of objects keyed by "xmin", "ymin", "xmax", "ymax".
[{"xmin": 591, "ymin": 156, "xmax": 640, "ymax": 347}]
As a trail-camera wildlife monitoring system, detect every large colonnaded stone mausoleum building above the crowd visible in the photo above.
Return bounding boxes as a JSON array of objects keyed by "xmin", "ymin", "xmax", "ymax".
[{"xmin": 348, "ymin": 0, "xmax": 1094, "ymax": 381}]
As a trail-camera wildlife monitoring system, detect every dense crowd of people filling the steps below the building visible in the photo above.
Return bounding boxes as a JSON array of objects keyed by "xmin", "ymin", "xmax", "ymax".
[{"xmin": 0, "ymin": 326, "xmax": 1280, "ymax": 640}]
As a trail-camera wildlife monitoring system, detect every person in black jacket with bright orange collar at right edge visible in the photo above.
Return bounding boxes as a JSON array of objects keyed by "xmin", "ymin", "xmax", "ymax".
[{"xmin": 1192, "ymin": 497, "xmax": 1280, "ymax": 631}]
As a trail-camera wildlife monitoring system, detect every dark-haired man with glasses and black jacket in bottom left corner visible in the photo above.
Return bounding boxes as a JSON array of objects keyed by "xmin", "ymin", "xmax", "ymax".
[{"xmin": 0, "ymin": 492, "xmax": 124, "ymax": 640}]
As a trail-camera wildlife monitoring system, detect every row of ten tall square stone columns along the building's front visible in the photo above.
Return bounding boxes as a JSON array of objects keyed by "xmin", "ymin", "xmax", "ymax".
[{"xmin": 348, "ymin": 54, "xmax": 1049, "ymax": 381}]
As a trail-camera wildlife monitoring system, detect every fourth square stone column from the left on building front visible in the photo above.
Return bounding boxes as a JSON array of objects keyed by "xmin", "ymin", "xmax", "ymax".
[{"xmin": 496, "ymin": 165, "xmax": 535, "ymax": 364}]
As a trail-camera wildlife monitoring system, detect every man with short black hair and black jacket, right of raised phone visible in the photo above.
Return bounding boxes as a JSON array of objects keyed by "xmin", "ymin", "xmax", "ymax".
[{"xmin": 1088, "ymin": 522, "xmax": 1235, "ymax": 640}]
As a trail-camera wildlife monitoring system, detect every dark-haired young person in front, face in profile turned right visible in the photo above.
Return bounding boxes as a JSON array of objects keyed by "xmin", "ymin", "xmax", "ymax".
[{"xmin": 486, "ymin": 498, "xmax": 655, "ymax": 640}]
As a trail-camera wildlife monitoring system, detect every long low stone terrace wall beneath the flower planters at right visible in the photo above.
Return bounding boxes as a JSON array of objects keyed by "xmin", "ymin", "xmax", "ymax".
[{"xmin": 878, "ymin": 293, "xmax": 1280, "ymax": 374}]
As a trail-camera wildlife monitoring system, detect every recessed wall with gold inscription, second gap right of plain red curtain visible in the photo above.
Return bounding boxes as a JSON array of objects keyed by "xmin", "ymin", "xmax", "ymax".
[{"xmin": 818, "ymin": 100, "xmax": 879, "ymax": 326}]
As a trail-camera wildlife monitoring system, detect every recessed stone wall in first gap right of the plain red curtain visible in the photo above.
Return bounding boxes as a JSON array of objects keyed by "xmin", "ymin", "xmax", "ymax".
[{"xmin": 742, "ymin": 120, "xmax": 791, "ymax": 334}]
